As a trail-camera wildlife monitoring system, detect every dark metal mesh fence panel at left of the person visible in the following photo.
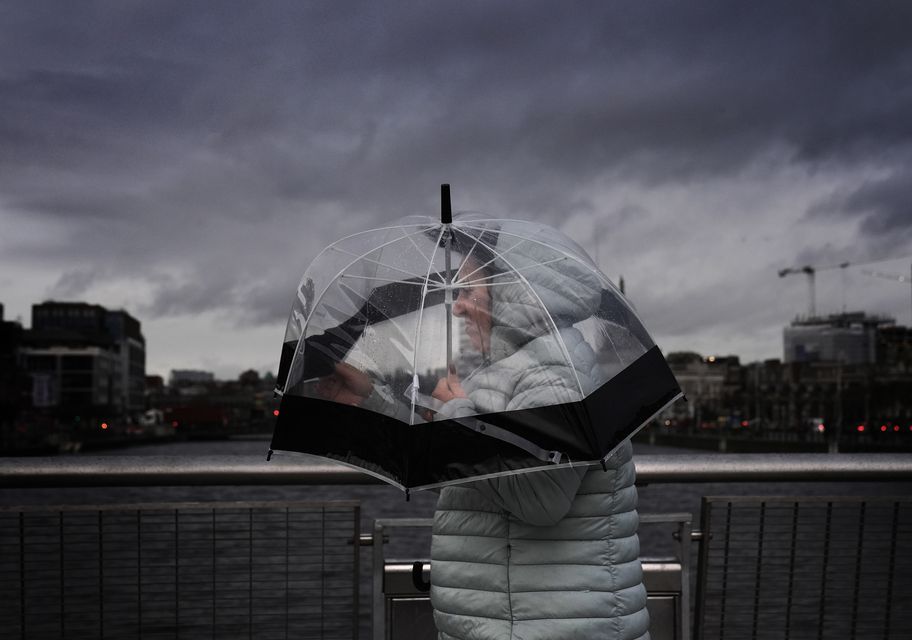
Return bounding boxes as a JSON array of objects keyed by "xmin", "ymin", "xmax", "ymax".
[{"xmin": 0, "ymin": 501, "xmax": 360, "ymax": 640}]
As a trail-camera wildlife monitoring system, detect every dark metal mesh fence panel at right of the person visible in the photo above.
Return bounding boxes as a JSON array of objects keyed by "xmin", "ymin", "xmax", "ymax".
[{"xmin": 695, "ymin": 496, "xmax": 912, "ymax": 640}]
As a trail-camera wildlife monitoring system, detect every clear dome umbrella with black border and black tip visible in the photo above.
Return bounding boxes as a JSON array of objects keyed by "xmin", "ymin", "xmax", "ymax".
[{"xmin": 270, "ymin": 185, "xmax": 682, "ymax": 491}]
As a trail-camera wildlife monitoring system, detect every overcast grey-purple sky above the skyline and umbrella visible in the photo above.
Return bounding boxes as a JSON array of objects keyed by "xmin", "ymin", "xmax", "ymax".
[{"xmin": 0, "ymin": 0, "xmax": 912, "ymax": 377}]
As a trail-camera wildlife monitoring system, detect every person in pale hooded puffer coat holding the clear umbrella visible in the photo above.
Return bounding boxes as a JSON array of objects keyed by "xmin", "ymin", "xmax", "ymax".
[{"xmin": 318, "ymin": 241, "xmax": 649, "ymax": 640}]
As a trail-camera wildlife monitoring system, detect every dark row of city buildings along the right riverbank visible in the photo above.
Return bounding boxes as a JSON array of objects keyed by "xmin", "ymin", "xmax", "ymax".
[{"xmin": 665, "ymin": 313, "xmax": 912, "ymax": 438}]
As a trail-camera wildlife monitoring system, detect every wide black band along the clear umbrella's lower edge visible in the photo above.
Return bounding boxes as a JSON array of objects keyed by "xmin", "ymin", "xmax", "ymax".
[{"xmin": 271, "ymin": 347, "xmax": 681, "ymax": 487}]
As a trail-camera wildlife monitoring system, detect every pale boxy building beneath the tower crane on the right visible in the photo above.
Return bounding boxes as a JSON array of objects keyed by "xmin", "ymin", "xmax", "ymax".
[{"xmin": 783, "ymin": 311, "xmax": 894, "ymax": 364}]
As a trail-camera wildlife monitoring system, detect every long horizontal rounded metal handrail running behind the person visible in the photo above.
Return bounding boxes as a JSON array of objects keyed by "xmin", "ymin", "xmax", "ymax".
[{"xmin": 0, "ymin": 453, "xmax": 912, "ymax": 488}]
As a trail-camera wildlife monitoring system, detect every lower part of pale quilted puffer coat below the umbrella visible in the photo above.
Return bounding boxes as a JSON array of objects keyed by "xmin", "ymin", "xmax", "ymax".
[{"xmin": 431, "ymin": 442, "xmax": 649, "ymax": 640}]
